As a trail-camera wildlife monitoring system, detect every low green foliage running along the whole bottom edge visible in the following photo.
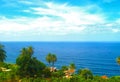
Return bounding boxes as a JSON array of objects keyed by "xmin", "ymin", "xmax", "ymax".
[{"xmin": 0, "ymin": 65, "xmax": 120, "ymax": 82}]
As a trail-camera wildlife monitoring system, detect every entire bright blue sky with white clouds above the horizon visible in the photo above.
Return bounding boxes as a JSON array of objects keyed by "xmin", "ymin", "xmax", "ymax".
[{"xmin": 0, "ymin": 0, "xmax": 120, "ymax": 42}]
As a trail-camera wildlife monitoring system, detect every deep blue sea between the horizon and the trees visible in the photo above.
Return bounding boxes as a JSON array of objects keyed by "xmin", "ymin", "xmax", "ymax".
[{"xmin": 1, "ymin": 42, "xmax": 120, "ymax": 76}]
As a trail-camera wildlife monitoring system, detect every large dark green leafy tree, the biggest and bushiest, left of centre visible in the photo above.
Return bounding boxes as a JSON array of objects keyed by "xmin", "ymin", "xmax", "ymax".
[{"xmin": 16, "ymin": 47, "xmax": 45, "ymax": 77}]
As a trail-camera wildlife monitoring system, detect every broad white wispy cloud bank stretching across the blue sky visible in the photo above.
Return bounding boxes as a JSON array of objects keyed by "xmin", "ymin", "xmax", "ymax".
[{"xmin": 0, "ymin": 2, "xmax": 120, "ymax": 40}]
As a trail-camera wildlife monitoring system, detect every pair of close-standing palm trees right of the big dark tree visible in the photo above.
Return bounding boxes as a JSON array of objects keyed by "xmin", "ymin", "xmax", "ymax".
[{"xmin": 46, "ymin": 53, "xmax": 57, "ymax": 67}]
